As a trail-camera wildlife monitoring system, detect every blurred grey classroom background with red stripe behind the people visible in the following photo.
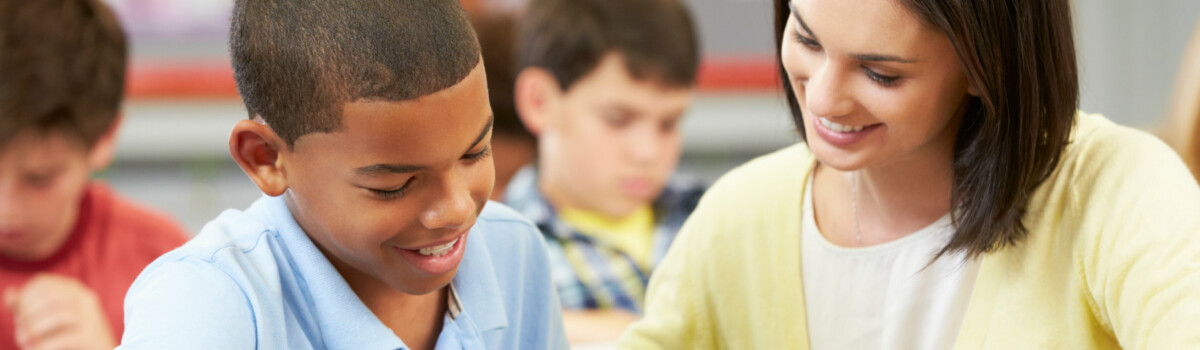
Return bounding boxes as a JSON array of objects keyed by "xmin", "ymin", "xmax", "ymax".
[{"xmin": 97, "ymin": 0, "xmax": 1200, "ymax": 233}]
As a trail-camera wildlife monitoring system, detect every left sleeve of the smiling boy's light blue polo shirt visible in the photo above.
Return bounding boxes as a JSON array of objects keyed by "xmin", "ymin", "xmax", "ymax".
[{"xmin": 118, "ymin": 258, "xmax": 257, "ymax": 349}]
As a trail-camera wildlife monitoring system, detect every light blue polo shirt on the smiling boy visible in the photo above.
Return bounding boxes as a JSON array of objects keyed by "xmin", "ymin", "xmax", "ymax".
[{"xmin": 119, "ymin": 197, "xmax": 568, "ymax": 349}]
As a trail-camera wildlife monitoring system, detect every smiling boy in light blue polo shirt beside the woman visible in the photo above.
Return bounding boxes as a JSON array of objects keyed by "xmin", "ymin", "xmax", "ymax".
[{"xmin": 121, "ymin": 0, "xmax": 566, "ymax": 349}]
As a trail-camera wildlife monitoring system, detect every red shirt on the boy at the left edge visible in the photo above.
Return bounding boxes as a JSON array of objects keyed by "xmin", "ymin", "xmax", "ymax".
[{"xmin": 0, "ymin": 182, "xmax": 187, "ymax": 349}]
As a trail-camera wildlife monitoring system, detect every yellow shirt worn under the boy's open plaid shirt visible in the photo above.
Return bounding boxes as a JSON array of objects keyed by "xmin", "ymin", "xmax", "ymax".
[{"xmin": 558, "ymin": 205, "xmax": 654, "ymax": 271}]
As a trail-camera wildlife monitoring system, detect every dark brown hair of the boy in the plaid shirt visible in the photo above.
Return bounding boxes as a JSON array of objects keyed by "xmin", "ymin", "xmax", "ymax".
[{"xmin": 518, "ymin": 0, "xmax": 700, "ymax": 91}]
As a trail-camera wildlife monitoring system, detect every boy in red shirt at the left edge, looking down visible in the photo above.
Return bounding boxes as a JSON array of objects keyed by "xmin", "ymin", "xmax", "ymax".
[{"xmin": 0, "ymin": 0, "xmax": 186, "ymax": 349}]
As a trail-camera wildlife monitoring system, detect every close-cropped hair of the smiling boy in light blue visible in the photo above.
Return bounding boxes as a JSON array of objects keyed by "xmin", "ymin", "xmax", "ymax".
[{"xmin": 229, "ymin": 0, "xmax": 479, "ymax": 146}]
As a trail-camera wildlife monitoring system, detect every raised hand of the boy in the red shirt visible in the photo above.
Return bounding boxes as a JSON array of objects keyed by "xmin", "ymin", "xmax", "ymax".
[{"xmin": 4, "ymin": 273, "xmax": 116, "ymax": 350}]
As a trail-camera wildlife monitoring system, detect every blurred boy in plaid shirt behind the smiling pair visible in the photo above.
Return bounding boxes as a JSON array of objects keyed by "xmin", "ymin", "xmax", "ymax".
[{"xmin": 506, "ymin": 0, "xmax": 702, "ymax": 343}]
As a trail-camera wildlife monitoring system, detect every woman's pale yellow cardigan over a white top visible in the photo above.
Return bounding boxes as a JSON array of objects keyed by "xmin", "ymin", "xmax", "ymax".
[{"xmin": 619, "ymin": 114, "xmax": 1200, "ymax": 349}]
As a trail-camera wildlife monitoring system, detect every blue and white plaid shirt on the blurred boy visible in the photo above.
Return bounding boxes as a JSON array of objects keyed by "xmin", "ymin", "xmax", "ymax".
[{"xmin": 504, "ymin": 167, "xmax": 704, "ymax": 314}]
